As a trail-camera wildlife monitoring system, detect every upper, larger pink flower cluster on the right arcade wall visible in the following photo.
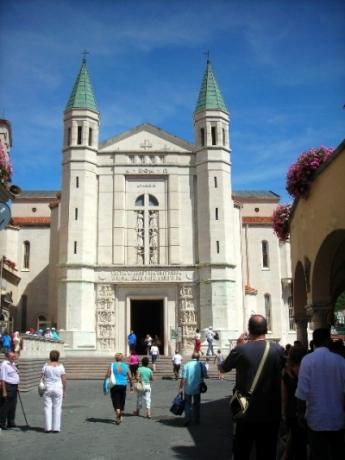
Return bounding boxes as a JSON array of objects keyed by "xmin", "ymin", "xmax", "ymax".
[{"xmin": 286, "ymin": 146, "xmax": 334, "ymax": 198}]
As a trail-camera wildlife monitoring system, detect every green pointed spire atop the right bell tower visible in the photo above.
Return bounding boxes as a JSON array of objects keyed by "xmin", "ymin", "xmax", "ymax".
[{"xmin": 195, "ymin": 59, "xmax": 228, "ymax": 113}]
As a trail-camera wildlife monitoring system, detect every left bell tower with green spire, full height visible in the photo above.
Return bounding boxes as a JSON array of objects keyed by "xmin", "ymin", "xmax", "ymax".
[{"xmin": 58, "ymin": 56, "xmax": 99, "ymax": 348}]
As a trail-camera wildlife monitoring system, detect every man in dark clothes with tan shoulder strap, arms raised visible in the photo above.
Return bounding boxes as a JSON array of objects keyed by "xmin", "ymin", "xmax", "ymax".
[{"xmin": 222, "ymin": 315, "xmax": 284, "ymax": 460}]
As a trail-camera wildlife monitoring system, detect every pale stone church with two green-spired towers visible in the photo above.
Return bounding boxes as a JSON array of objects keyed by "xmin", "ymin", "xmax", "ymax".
[{"xmin": 1, "ymin": 60, "xmax": 295, "ymax": 354}]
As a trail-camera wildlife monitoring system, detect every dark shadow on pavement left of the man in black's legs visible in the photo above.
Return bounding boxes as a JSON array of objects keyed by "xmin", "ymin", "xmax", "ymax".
[{"xmin": 159, "ymin": 396, "xmax": 233, "ymax": 460}]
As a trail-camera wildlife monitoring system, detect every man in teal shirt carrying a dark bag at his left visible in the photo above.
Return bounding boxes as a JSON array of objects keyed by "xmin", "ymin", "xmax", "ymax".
[{"xmin": 180, "ymin": 352, "xmax": 207, "ymax": 426}]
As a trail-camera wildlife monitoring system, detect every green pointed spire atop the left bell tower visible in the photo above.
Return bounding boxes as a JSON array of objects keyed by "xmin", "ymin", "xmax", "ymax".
[{"xmin": 65, "ymin": 57, "xmax": 98, "ymax": 112}]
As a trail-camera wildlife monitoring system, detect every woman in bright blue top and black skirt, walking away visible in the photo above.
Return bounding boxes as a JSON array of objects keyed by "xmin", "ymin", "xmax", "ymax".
[{"xmin": 103, "ymin": 353, "xmax": 133, "ymax": 425}]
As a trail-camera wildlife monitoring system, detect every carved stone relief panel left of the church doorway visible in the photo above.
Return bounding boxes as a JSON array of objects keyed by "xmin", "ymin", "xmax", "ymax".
[{"xmin": 96, "ymin": 284, "xmax": 115, "ymax": 351}]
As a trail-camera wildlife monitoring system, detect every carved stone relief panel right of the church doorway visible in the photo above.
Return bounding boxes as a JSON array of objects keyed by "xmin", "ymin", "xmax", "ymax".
[{"xmin": 179, "ymin": 285, "xmax": 198, "ymax": 351}]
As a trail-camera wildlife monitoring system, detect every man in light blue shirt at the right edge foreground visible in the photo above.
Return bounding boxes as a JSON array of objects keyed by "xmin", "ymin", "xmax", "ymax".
[{"xmin": 296, "ymin": 329, "xmax": 345, "ymax": 460}]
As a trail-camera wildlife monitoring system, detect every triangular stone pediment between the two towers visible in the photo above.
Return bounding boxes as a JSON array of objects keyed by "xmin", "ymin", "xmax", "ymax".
[{"xmin": 99, "ymin": 123, "xmax": 194, "ymax": 153}]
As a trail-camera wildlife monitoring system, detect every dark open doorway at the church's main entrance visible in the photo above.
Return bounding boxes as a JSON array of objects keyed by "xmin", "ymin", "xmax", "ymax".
[{"xmin": 131, "ymin": 299, "xmax": 164, "ymax": 355}]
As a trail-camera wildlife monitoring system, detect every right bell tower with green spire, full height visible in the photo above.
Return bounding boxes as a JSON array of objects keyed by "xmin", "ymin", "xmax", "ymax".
[{"xmin": 194, "ymin": 59, "xmax": 236, "ymax": 343}]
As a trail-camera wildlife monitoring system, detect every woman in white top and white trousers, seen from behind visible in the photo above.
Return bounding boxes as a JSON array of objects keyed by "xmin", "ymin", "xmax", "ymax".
[{"xmin": 42, "ymin": 350, "xmax": 66, "ymax": 433}]
